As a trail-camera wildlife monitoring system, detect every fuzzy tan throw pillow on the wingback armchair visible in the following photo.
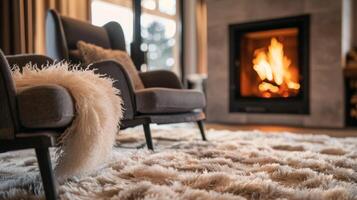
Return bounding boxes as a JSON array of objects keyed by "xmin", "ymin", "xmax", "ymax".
[{"xmin": 77, "ymin": 41, "xmax": 145, "ymax": 90}]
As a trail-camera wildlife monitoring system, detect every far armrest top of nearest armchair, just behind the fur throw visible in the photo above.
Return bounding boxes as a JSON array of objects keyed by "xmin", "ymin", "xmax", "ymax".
[{"xmin": 6, "ymin": 54, "xmax": 53, "ymax": 69}]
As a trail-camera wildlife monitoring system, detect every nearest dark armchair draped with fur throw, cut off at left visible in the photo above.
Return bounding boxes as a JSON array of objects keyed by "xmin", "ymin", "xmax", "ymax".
[{"xmin": 0, "ymin": 51, "xmax": 75, "ymax": 200}]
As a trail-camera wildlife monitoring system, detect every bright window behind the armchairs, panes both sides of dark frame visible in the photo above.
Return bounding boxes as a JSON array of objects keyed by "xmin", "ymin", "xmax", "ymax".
[{"xmin": 91, "ymin": 0, "xmax": 181, "ymax": 75}]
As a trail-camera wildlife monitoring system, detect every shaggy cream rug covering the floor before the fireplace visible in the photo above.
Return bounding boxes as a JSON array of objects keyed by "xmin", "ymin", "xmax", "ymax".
[{"xmin": 0, "ymin": 125, "xmax": 357, "ymax": 200}]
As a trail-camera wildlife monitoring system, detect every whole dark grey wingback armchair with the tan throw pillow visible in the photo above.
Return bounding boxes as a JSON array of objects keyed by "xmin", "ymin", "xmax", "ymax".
[{"xmin": 46, "ymin": 10, "xmax": 206, "ymax": 150}]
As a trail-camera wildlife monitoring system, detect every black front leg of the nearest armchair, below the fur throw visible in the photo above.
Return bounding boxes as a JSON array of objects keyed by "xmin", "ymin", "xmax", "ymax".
[{"xmin": 36, "ymin": 148, "xmax": 57, "ymax": 200}]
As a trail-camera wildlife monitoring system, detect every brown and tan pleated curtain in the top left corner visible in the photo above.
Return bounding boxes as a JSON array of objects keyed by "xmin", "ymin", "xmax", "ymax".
[{"xmin": 0, "ymin": 0, "xmax": 90, "ymax": 54}]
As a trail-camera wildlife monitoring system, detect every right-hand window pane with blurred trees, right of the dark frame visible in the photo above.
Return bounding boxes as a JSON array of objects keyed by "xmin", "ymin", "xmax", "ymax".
[{"xmin": 141, "ymin": 0, "xmax": 180, "ymax": 74}]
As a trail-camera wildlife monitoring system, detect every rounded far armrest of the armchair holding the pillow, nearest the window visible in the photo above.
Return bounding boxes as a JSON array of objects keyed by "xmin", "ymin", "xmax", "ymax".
[{"xmin": 139, "ymin": 70, "xmax": 183, "ymax": 89}]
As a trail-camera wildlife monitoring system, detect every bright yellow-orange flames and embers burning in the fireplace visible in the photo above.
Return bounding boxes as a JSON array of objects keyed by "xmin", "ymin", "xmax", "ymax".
[{"xmin": 253, "ymin": 38, "xmax": 300, "ymax": 98}]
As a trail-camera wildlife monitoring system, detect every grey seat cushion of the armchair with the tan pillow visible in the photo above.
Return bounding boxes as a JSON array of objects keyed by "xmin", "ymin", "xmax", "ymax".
[{"xmin": 135, "ymin": 88, "xmax": 206, "ymax": 114}]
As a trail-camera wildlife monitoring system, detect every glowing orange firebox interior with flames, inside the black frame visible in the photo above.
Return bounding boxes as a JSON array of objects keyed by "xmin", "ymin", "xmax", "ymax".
[{"xmin": 241, "ymin": 29, "xmax": 300, "ymax": 98}]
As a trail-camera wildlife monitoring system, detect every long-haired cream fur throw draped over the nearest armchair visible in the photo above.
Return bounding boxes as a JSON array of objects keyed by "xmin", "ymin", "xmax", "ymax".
[{"xmin": 13, "ymin": 62, "xmax": 123, "ymax": 181}]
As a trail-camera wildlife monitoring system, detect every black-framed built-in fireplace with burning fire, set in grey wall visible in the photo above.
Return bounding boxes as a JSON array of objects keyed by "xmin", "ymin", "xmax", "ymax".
[{"xmin": 229, "ymin": 15, "xmax": 310, "ymax": 114}]
